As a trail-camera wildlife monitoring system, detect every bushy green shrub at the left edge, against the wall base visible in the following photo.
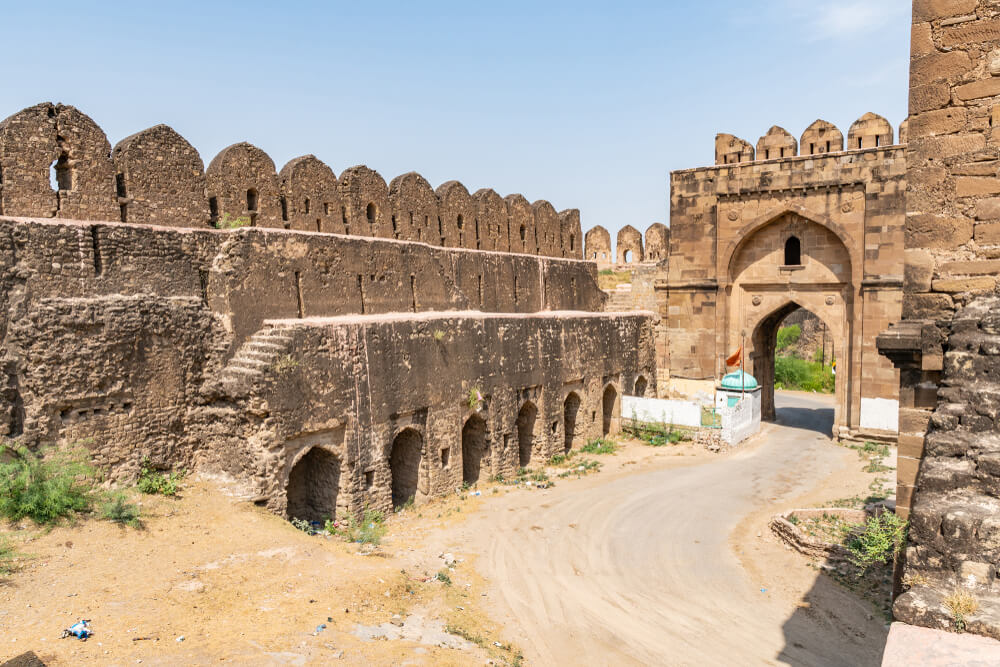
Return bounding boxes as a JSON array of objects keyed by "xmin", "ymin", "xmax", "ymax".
[{"xmin": 0, "ymin": 444, "xmax": 96, "ymax": 524}]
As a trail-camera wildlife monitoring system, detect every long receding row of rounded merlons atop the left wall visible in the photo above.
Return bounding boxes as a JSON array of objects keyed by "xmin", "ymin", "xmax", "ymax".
[{"xmin": 0, "ymin": 102, "xmax": 582, "ymax": 259}]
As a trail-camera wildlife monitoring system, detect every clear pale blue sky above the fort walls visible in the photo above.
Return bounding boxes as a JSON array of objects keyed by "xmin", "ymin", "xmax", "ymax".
[{"xmin": 0, "ymin": 0, "xmax": 910, "ymax": 244}]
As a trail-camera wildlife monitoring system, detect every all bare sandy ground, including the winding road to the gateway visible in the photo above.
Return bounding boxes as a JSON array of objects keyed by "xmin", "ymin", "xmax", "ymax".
[{"xmin": 0, "ymin": 397, "xmax": 885, "ymax": 665}]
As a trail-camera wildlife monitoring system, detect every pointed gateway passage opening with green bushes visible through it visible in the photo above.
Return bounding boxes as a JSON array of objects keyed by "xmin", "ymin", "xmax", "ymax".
[{"xmin": 750, "ymin": 301, "xmax": 839, "ymax": 435}]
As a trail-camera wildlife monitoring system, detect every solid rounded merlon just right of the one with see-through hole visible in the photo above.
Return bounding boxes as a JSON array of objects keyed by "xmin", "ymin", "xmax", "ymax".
[{"xmin": 112, "ymin": 125, "xmax": 211, "ymax": 227}]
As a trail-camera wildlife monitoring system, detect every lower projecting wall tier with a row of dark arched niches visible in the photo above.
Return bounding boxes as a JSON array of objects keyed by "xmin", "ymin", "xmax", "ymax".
[{"xmin": 233, "ymin": 313, "xmax": 655, "ymax": 512}]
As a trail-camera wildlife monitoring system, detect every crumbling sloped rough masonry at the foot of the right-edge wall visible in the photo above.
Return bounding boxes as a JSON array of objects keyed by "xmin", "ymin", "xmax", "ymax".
[{"xmin": 893, "ymin": 296, "xmax": 1000, "ymax": 639}]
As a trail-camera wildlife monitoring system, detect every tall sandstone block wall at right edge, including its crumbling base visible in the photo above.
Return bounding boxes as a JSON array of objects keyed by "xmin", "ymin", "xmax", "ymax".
[{"xmin": 878, "ymin": 0, "xmax": 1000, "ymax": 638}]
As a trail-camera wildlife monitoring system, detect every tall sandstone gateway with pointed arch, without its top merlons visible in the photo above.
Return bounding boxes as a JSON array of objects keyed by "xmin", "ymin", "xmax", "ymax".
[{"xmin": 656, "ymin": 135, "xmax": 906, "ymax": 437}]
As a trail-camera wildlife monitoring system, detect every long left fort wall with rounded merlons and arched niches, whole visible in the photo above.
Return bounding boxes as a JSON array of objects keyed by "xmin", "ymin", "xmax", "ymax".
[{"xmin": 0, "ymin": 104, "xmax": 656, "ymax": 518}]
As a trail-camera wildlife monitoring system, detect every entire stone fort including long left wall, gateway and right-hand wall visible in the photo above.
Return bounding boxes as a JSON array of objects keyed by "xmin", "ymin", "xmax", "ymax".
[{"xmin": 7, "ymin": 0, "xmax": 1000, "ymax": 652}]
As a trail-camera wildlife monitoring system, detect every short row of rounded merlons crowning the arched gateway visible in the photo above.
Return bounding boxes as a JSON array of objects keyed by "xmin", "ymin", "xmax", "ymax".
[{"xmin": 715, "ymin": 112, "xmax": 906, "ymax": 165}]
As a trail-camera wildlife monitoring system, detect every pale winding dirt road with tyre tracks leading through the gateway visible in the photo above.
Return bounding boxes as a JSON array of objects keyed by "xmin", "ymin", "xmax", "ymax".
[{"xmin": 463, "ymin": 395, "xmax": 885, "ymax": 667}]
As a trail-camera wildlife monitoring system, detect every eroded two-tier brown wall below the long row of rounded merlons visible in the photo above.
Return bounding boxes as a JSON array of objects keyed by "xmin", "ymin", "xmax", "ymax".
[{"xmin": 0, "ymin": 217, "xmax": 640, "ymax": 511}]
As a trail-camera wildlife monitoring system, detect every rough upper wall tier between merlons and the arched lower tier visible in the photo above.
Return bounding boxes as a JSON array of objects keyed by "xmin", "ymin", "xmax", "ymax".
[{"xmin": 0, "ymin": 217, "xmax": 603, "ymax": 488}]
